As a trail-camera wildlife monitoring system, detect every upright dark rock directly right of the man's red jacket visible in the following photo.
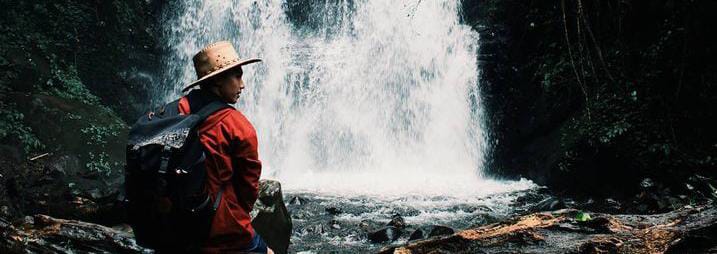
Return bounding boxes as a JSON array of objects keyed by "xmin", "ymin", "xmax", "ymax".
[{"xmin": 251, "ymin": 180, "xmax": 293, "ymax": 253}]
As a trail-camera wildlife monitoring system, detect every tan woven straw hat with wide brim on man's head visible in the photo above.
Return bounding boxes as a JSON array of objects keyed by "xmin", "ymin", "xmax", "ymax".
[{"xmin": 182, "ymin": 41, "xmax": 261, "ymax": 92}]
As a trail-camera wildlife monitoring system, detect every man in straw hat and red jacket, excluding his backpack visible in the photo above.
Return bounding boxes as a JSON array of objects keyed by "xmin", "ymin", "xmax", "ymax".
[{"xmin": 178, "ymin": 41, "xmax": 273, "ymax": 253}]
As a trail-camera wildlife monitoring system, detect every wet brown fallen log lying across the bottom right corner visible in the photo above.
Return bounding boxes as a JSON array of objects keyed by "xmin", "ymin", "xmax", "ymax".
[{"xmin": 380, "ymin": 206, "xmax": 717, "ymax": 254}]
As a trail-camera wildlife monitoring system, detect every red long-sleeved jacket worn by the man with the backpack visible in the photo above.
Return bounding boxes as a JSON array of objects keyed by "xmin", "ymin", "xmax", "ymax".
[{"xmin": 179, "ymin": 96, "xmax": 261, "ymax": 253}]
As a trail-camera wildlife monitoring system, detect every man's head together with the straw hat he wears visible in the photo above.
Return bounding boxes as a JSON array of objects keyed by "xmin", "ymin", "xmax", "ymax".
[{"xmin": 182, "ymin": 41, "xmax": 261, "ymax": 99}]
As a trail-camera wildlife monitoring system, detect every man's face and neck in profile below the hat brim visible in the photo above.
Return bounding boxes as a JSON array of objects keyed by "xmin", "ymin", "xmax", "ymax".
[{"xmin": 199, "ymin": 66, "xmax": 244, "ymax": 103}]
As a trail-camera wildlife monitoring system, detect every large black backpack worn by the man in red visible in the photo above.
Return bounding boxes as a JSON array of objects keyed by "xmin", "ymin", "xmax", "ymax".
[{"xmin": 124, "ymin": 100, "xmax": 230, "ymax": 252}]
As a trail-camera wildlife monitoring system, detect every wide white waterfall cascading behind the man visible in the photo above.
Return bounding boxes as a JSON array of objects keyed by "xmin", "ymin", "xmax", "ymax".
[{"xmin": 158, "ymin": 0, "xmax": 526, "ymax": 196}]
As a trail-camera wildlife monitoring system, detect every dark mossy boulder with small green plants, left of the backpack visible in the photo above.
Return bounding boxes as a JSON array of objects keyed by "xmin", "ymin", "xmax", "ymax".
[{"xmin": 11, "ymin": 94, "xmax": 128, "ymax": 179}]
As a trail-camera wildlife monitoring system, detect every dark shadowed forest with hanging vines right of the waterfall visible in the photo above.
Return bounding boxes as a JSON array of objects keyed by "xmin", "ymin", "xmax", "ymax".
[{"xmin": 464, "ymin": 0, "xmax": 717, "ymax": 208}]
